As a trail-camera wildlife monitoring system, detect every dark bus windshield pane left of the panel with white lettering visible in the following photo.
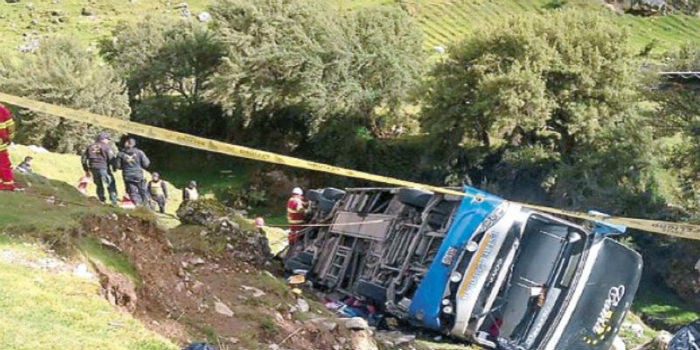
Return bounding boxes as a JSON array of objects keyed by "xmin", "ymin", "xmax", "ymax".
[{"xmin": 480, "ymin": 214, "xmax": 586, "ymax": 344}]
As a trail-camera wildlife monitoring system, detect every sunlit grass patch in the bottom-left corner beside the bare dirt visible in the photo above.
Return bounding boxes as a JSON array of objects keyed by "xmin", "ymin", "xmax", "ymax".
[{"xmin": 0, "ymin": 242, "xmax": 177, "ymax": 350}]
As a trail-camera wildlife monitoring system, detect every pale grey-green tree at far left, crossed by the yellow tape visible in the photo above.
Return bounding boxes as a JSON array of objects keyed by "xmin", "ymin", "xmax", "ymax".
[{"xmin": 0, "ymin": 36, "xmax": 130, "ymax": 152}]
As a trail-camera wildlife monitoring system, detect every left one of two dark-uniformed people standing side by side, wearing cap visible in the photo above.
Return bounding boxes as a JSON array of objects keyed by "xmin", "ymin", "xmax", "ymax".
[{"xmin": 80, "ymin": 132, "xmax": 117, "ymax": 205}]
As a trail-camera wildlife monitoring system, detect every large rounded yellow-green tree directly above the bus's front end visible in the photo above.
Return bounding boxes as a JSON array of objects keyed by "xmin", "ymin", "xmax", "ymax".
[{"xmin": 423, "ymin": 11, "xmax": 636, "ymax": 158}]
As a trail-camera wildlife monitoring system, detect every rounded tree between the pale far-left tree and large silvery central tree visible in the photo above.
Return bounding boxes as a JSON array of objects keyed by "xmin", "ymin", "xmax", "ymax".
[{"xmin": 101, "ymin": 16, "xmax": 225, "ymax": 104}]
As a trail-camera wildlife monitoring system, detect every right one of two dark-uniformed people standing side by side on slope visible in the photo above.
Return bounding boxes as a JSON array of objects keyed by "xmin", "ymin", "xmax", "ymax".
[{"xmin": 114, "ymin": 138, "xmax": 151, "ymax": 206}]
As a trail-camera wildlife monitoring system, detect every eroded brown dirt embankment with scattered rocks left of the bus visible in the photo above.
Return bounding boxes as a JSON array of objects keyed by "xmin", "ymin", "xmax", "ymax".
[{"xmin": 79, "ymin": 211, "xmax": 376, "ymax": 350}]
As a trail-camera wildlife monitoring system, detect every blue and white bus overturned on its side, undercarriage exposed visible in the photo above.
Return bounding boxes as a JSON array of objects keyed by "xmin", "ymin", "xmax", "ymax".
[{"xmin": 285, "ymin": 187, "xmax": 642, "ymax": 350}]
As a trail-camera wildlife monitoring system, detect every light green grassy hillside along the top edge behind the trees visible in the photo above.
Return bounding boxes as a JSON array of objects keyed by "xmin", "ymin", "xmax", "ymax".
[{"xmin": 0, "ymin": 0, "xmax": 700, "ymax": 54}]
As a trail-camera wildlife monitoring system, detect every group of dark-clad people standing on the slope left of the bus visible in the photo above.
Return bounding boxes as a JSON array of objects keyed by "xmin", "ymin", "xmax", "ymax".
[{"xmin": 78, "ymin": 132, "xmax": 199, "ymax": 213}]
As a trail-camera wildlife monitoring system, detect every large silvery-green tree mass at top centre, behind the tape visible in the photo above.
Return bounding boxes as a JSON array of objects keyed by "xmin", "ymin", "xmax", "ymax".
[{"xmin": 202, "ymin": 0, "xmax": 422, "ymax": 150}]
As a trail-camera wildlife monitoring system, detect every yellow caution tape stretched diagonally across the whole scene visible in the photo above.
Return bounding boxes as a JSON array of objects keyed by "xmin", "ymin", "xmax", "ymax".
[{"xmin": 0, "ymin": 93, "xmax": 700, "ymax": 240}]
